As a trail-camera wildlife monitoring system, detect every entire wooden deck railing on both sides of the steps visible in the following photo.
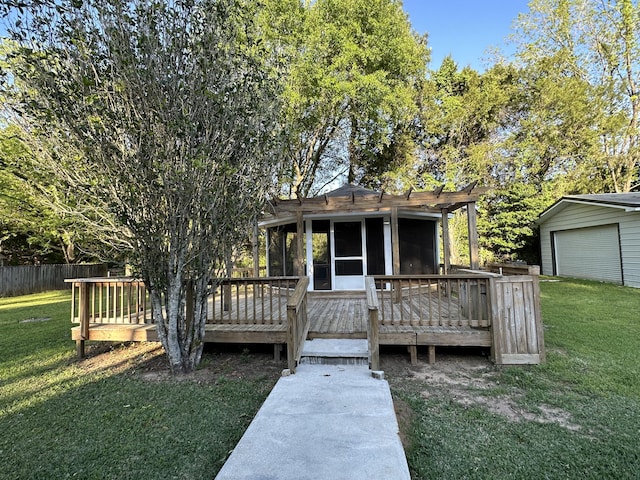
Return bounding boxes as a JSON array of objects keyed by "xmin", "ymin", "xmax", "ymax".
[{"xmin": 69, "ymin": 271, "xmax": 544, "ymax": 371}]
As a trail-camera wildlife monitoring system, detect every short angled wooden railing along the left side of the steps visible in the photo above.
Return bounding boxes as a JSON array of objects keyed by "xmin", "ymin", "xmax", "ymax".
[{"xmin": 287, "ymin": 277, "xmax": 309, "ymax": 373}]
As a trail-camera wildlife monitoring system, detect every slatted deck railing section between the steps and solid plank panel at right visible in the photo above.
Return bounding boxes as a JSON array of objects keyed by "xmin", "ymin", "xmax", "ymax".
[{"xmin": 370, "ymin": 274, "xmax": 492, "ymax": 327}]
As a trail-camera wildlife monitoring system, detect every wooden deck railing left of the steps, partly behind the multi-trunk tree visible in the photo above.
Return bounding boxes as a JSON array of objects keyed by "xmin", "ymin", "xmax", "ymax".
[{"xmin": 69, "ymin": 277, "xmax": 309, "ymax": 366}]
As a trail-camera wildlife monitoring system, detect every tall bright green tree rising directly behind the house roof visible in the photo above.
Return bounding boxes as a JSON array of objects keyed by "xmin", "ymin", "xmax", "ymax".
[{"xmin": 275, "ymin": 0, "xmax": 428, "ymax": 196}]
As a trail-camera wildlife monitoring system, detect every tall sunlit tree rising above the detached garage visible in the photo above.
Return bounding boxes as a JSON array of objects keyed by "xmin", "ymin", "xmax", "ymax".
[{"xmin": 515, "ymin": 0, "xmax": 640, "ymax": 192}]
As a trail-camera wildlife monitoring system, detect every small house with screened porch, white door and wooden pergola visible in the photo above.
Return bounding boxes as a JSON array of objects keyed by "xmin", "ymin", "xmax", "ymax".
[{"xmin": 260, "ymin": 184, "xmax": 482, "ymax": 291}]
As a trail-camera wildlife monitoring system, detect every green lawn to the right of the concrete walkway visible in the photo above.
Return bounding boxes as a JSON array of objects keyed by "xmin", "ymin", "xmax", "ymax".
[{"xmin": 389, "ymin": 280, "xmax": 640, "ymax": 479}]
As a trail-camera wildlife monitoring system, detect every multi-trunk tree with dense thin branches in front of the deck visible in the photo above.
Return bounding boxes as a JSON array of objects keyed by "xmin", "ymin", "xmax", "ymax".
[{"xmin": 5, "ymin": 0, "xmax": 279, "ymax": 372}]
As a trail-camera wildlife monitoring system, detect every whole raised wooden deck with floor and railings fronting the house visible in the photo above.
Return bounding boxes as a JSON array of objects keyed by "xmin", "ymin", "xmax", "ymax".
[{"xmin": 71, "ymin": 273, "xmax": 544, "ymax": 365}]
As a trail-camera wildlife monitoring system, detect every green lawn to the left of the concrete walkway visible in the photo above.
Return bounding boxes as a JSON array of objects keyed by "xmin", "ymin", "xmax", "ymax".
[{"xmin": 0, "ymin": 292, "xmax": 275, "ymax": 479}]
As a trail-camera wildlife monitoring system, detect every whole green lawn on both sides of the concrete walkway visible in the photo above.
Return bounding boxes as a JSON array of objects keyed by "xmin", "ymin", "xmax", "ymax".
[{"xmin": 5, "ymin": 281, "xmax": 640, "ymax": 480}]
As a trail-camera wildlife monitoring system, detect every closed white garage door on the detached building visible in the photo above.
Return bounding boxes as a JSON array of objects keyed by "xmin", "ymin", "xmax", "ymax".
[{"xmin": 554, "ymin": 225, "xmax": 622, "ymax": 283}]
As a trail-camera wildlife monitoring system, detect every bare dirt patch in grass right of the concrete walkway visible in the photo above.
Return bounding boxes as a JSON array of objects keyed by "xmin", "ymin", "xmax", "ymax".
[{"xmin": 381, "ymin": 346, "xmax": 580, "ymax": 436}]
